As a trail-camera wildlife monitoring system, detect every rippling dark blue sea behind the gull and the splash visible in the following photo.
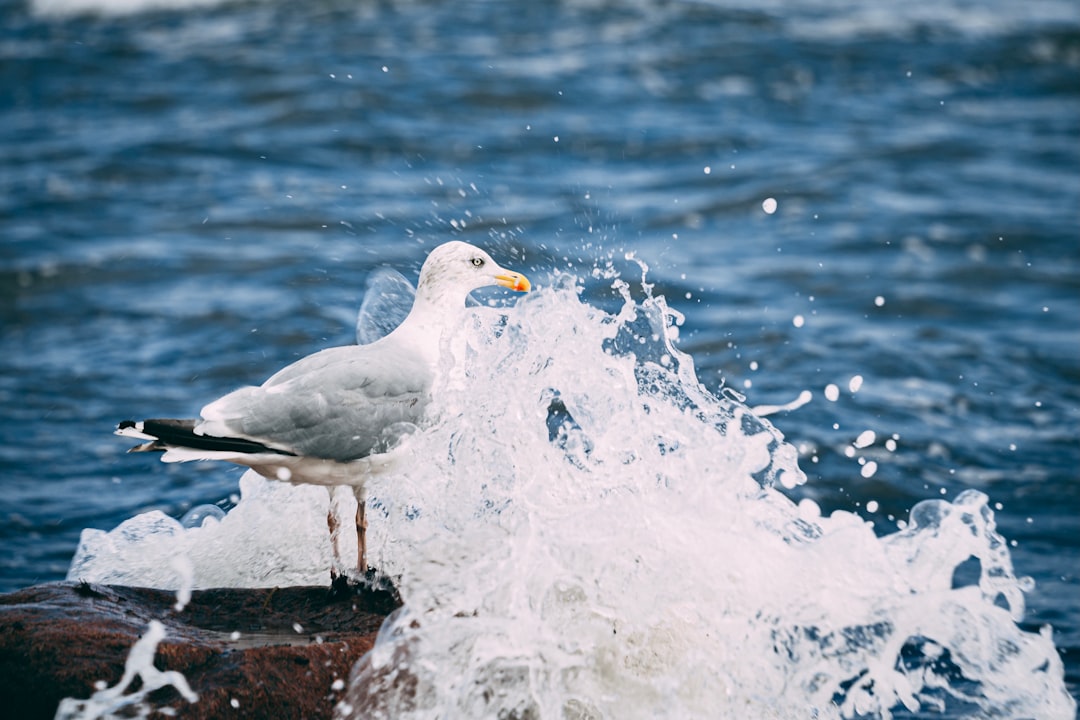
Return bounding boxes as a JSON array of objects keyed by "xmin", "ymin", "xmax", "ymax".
[{"xmin": 0, "ymin": 0, "xmax": 1080, "ymax": 712}]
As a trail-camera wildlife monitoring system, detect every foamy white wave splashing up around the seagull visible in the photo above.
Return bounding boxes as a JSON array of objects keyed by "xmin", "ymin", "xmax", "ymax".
[{"xmin": 69, "ymin": 266, "xmax": 1076, "ymax": 719}]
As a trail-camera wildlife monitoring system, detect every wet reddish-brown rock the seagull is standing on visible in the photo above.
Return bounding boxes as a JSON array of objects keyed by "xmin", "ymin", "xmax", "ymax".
[{"xmin": 0, "ymin": 582, "xmax": 400, "ymax": 720}]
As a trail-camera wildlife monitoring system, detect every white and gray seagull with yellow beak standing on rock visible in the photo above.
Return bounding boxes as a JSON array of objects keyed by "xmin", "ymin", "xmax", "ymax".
[{"xmin": 116, "ymin": 241, "xmax": 531, "ymax": 580}]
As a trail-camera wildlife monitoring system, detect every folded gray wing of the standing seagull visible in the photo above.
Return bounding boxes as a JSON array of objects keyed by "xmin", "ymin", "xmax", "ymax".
[{"xmin": 197, "ymin": 343, "xmax": 431, "ymax": 462}]
